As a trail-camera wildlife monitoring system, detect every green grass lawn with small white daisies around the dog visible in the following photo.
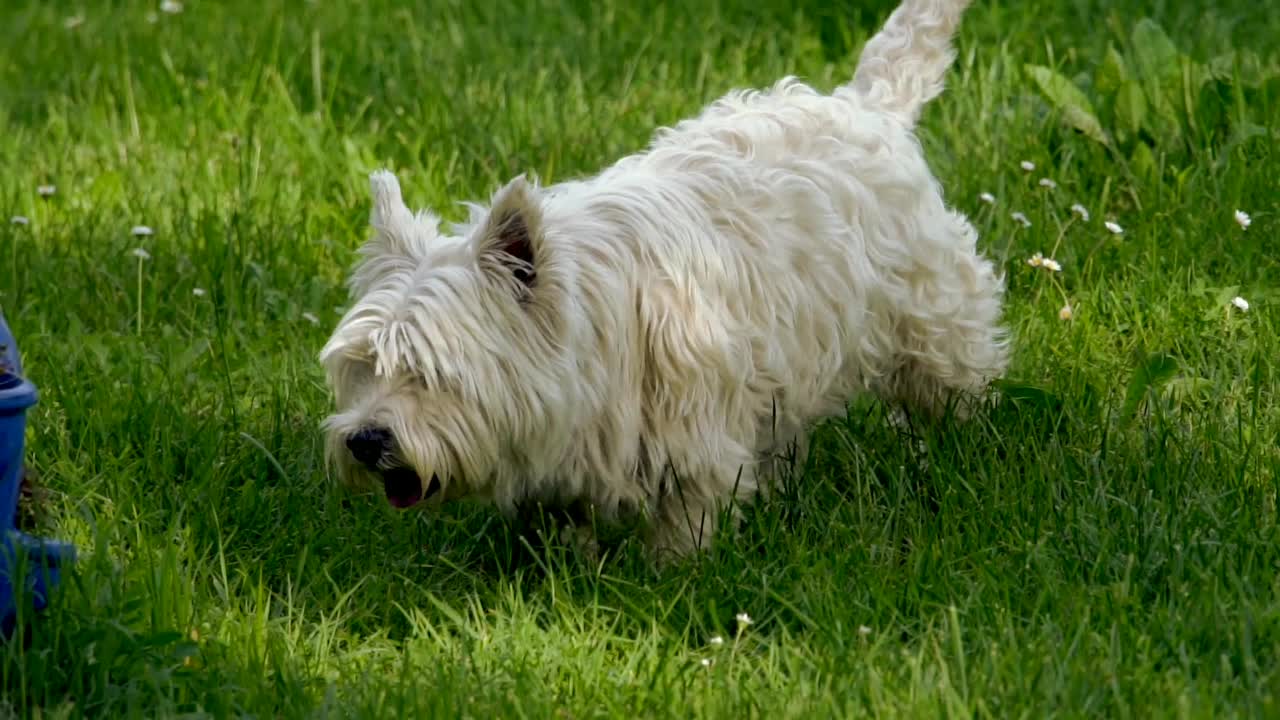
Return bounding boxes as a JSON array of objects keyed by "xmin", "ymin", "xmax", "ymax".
[{"xmin": 0, "ymin": 0, "xmax": 1280, "ymax": 719}]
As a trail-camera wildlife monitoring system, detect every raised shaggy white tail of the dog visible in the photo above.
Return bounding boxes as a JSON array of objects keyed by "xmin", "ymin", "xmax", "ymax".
[{"xmin": 851, "ymin": 0, "xmax": 972, "ymax": 127}]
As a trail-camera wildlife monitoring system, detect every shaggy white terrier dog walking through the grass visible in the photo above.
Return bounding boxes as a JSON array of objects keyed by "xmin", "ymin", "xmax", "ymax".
[{"xmin": 320, "ymin": 0, "xmax": 1007, "ymax": 555}]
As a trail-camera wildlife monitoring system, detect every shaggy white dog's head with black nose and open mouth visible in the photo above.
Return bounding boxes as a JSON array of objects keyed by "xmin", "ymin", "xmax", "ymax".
[{"xmin": 320, "ymin": 172, "xmax": 573, "ymax": 507}]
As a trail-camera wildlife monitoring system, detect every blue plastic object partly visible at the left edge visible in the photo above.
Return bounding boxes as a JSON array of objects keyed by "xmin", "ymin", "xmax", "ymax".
[{"xmin": 0, "ymin": 313, "xmax": 76, "ymax": 637}]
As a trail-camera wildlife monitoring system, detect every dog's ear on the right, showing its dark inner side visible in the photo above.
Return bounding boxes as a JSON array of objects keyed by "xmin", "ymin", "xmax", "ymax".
[{"xmin": 479, "ymin": 176, "xmax": 543, "ymax": 297}]
